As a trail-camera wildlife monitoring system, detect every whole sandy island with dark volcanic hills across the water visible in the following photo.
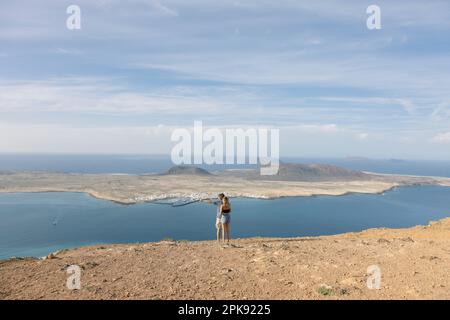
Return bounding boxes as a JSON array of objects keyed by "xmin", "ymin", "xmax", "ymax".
[{"xmin": 0, "ymin": 163, "xmax": 450, "ymax": 204}]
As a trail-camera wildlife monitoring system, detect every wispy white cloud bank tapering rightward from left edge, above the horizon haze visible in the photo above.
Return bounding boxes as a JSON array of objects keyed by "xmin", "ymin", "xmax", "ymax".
[{"xmin": 0, "ymin": 79, "xmax": 226, "ymax": 115}]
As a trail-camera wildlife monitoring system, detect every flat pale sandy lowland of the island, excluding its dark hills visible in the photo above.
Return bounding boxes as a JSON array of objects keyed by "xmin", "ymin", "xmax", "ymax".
[{"xmin": 0, "ymin": 172, "xmax": 450, "ymax": 204}]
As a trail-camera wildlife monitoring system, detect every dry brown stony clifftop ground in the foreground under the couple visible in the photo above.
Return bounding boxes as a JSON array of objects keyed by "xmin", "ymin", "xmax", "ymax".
[{"xmin": 0, "ymin": 218, "xmax": 450, "ymax": 299}]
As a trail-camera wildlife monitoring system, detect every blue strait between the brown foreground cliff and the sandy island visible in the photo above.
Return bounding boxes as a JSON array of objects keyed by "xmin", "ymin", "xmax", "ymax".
[{"xmin": 0, "ymin": 186, "xmax": 450, "ymax": 259}]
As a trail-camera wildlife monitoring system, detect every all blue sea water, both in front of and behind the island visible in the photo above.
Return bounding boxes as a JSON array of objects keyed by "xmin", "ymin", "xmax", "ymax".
[{"xmin": 0, "ymin": 154, "xmax": 450, "ymax": 259}]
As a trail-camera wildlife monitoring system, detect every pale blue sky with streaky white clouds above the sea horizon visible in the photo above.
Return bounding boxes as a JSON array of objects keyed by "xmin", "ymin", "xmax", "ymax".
[{"xmin": 0, "ymin": 0, "xmax": 450, "ymax": 160}]
